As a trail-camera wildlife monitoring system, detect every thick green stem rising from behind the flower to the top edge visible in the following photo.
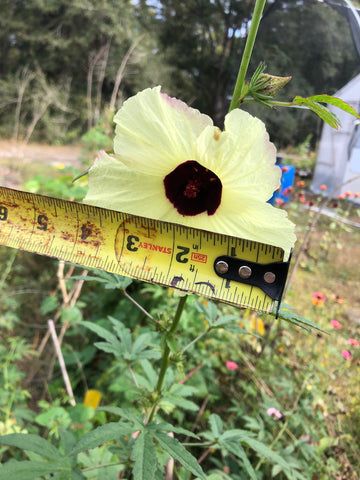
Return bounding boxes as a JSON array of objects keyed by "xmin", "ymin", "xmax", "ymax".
[{"xmin": 229, "ymin": 0, "xmax": 266, "ymax": 112}]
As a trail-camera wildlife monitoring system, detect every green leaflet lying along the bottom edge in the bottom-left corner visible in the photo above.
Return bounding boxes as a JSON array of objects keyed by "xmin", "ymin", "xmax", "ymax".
[{"xmin": 0, "ymin": 460, "xmax": 70, "ymax": 480}]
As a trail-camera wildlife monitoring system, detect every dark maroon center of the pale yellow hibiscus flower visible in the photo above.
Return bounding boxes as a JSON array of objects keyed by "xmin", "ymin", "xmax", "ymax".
[{"xmin": 164, "ymin": 160, "xmax": 222, "ymax": 216}]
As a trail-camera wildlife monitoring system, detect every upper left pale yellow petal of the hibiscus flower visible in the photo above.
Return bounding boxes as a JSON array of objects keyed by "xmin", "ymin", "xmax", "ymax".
[{"xmin": 114, "ymin": 87, "xmax": 212, "ymax": 176}]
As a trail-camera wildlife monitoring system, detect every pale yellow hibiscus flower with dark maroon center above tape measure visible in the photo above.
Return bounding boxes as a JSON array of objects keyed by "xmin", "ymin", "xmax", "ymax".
[{"xmin": 84, "ymin": 87, "xmax": 296, "ymax": 256}]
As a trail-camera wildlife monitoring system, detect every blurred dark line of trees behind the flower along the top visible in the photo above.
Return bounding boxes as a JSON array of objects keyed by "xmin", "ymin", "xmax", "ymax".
[{"xmin": 0, "ymin": 0, "xmax": 359, "ymax": 147}]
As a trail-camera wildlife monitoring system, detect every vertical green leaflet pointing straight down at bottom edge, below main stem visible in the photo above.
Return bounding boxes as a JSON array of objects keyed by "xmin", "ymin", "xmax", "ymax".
[{"xmin": 131, "ymin": 432, "xmax": 157, "ymax": 480}]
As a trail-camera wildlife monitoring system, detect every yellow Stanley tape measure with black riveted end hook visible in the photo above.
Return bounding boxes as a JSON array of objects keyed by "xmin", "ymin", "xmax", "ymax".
[{"xmin": 0, "ymin": 187, "xmax": 288, "ymax": 313}]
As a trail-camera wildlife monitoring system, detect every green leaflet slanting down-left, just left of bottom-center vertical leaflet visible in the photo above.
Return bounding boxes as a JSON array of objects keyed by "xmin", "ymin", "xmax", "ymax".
[{"xmin": 69, "ymin": 422, "xmax": 134, "ymax": 455}]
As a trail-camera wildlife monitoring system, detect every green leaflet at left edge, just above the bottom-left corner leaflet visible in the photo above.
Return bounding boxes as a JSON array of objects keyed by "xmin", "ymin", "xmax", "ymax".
[{"xmin": 0, "ymin": 433, "xmax": 62, "ymax": 461}]
